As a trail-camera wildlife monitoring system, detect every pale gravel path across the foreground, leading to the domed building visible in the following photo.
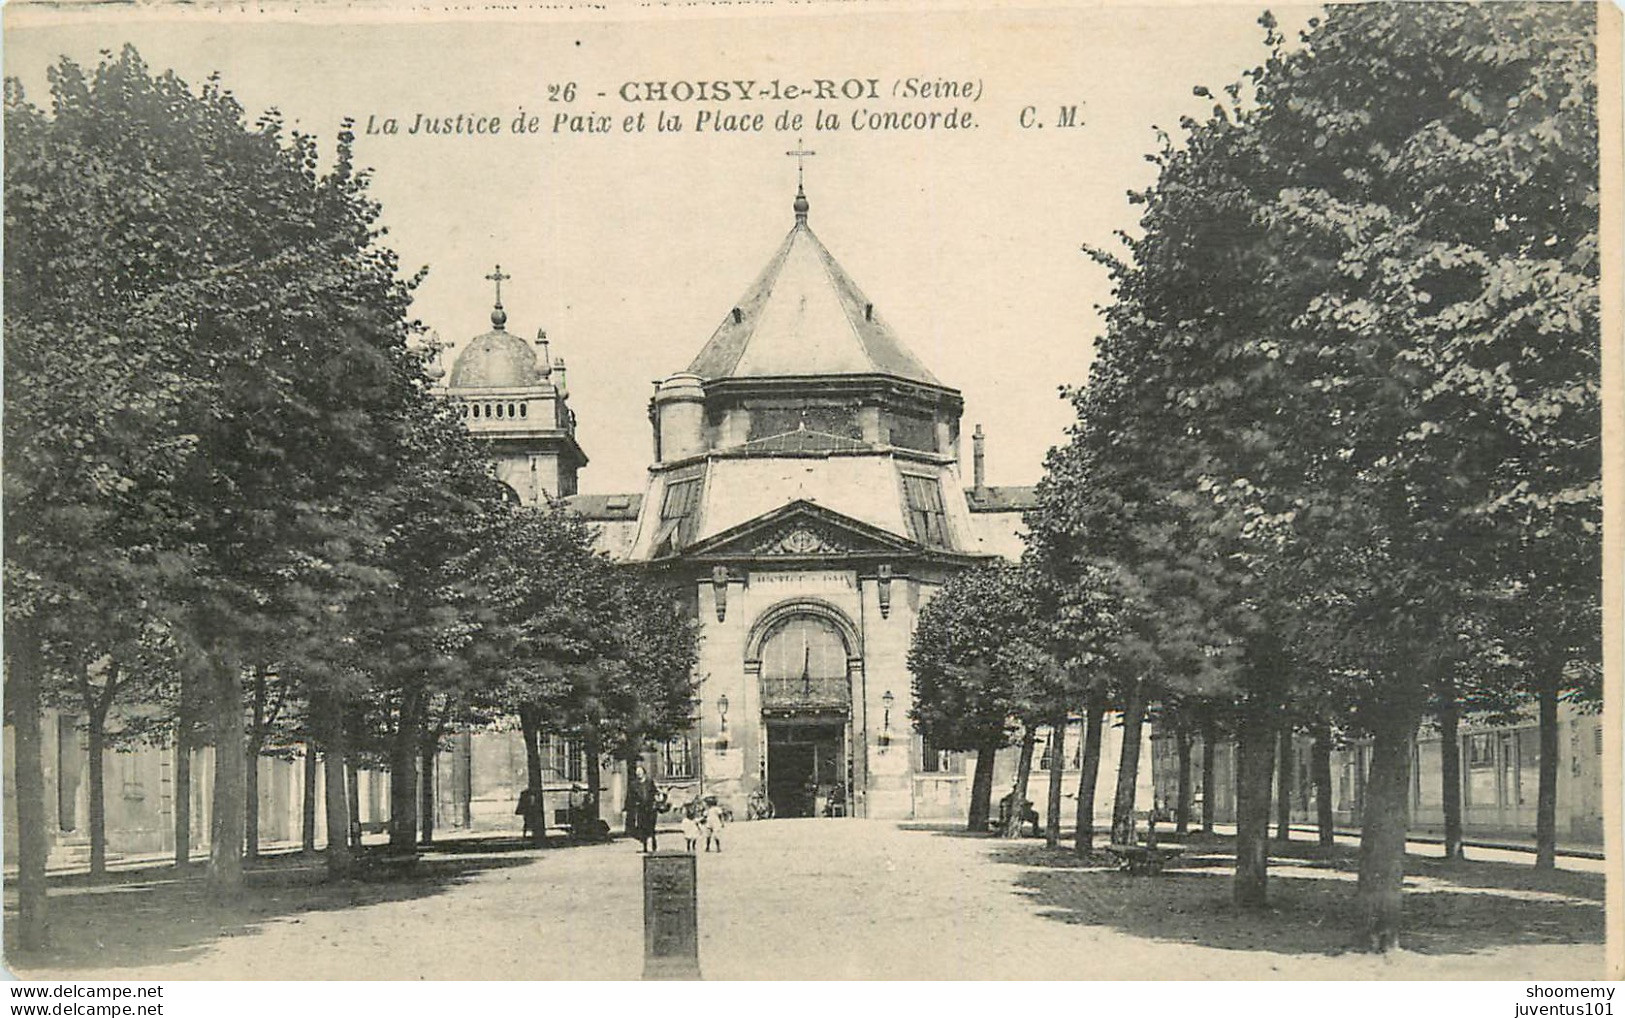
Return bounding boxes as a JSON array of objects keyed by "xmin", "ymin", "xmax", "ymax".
[{"xmin": 6, "ymin": 820, "xmax": 1604, "ymax": 979}]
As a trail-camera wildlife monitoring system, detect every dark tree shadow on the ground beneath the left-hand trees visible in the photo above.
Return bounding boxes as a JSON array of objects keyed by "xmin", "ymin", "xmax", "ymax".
[{"xmin": 5, "ymin": 837, "xmax": 540, "ymax": 974}]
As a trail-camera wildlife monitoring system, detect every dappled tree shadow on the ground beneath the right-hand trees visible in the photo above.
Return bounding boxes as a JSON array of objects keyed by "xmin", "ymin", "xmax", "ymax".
[{"xmin": 991, "ymin": 841, "xmax": 1604, "ymax": 955}]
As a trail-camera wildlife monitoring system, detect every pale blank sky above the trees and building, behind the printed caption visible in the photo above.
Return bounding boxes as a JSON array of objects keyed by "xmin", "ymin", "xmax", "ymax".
[{"xmin": 5, "ymin": 3, "xmax": 1315, "ymax": 493}]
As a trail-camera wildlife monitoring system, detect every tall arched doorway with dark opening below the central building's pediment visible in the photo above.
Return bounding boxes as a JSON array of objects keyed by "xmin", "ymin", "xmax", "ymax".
[{"xmin": 748, "ymin": 603, "xmax": 860, "ymax": 816}]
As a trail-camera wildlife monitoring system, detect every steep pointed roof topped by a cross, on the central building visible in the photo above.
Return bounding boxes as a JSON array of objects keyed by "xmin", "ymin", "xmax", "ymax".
[{"xmin": 689, "ymin": 192, "xmax": 943, "ymax": 387}]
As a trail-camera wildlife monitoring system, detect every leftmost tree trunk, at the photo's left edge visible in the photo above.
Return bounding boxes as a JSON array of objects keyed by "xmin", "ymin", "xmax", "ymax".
[{"xmin": 5, "ymin": 623, "xmax": 50, "ymax": 951}]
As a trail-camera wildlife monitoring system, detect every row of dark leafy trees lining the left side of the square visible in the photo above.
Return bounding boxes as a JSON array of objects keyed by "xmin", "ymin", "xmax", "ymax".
[{"xmin": 5, "ymin": 49, "xmax": 696, "ymax": 948}]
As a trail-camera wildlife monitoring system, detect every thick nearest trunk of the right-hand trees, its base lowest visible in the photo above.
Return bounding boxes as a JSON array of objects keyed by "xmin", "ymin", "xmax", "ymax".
[{"xmin": 1355, "ymin": 704, "xmax": 1420, "ymax": 951}]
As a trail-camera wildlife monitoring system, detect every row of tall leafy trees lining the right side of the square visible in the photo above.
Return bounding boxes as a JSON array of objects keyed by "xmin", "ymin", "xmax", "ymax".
[{"xmin": 915, "ymin": 3, "xmax": 1601, "ymax": 950}]
